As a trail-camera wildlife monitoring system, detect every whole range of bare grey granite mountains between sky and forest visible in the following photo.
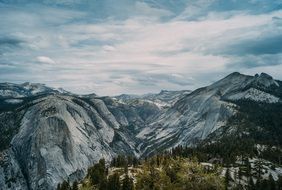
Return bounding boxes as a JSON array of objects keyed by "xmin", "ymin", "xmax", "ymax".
[{"xmin": 0, "ymin": 73, "xmax": 282, "ymax": 189}]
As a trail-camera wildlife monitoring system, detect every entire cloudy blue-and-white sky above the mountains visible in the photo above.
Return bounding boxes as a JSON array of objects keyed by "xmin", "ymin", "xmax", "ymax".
[{"xmin": 0, "ymin": 0, "xmax": 282, "ymax": 96}]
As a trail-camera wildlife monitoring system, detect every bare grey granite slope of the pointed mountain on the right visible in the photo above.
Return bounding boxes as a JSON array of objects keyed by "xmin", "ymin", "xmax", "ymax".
[{"xmin": 137, "ymin": 73, "xmax": 281, "ymax": 156}]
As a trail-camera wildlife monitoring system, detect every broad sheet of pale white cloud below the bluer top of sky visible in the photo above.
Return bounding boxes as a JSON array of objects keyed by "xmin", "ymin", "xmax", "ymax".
[{"xmin": 0, "ymin": 1, "xmax": 282, "ymax": 95}]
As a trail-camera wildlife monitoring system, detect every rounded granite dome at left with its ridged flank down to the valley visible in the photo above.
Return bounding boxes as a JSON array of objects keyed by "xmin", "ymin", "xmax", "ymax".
[{"xmin": 1, "ymin": 94, "xmax": 143, "ymax": 189}]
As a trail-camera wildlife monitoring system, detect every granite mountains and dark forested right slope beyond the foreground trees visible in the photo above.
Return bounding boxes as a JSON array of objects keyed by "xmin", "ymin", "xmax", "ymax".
[{"xmin": 0, "ymin": 72, "xmax": 282, "ymax": 190}]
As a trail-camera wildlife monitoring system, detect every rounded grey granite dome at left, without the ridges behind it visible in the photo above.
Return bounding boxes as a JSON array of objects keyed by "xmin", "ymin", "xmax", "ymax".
[{"xmin": 11, "ymin": 95, "xmax": 117, "ymax": 189}]
